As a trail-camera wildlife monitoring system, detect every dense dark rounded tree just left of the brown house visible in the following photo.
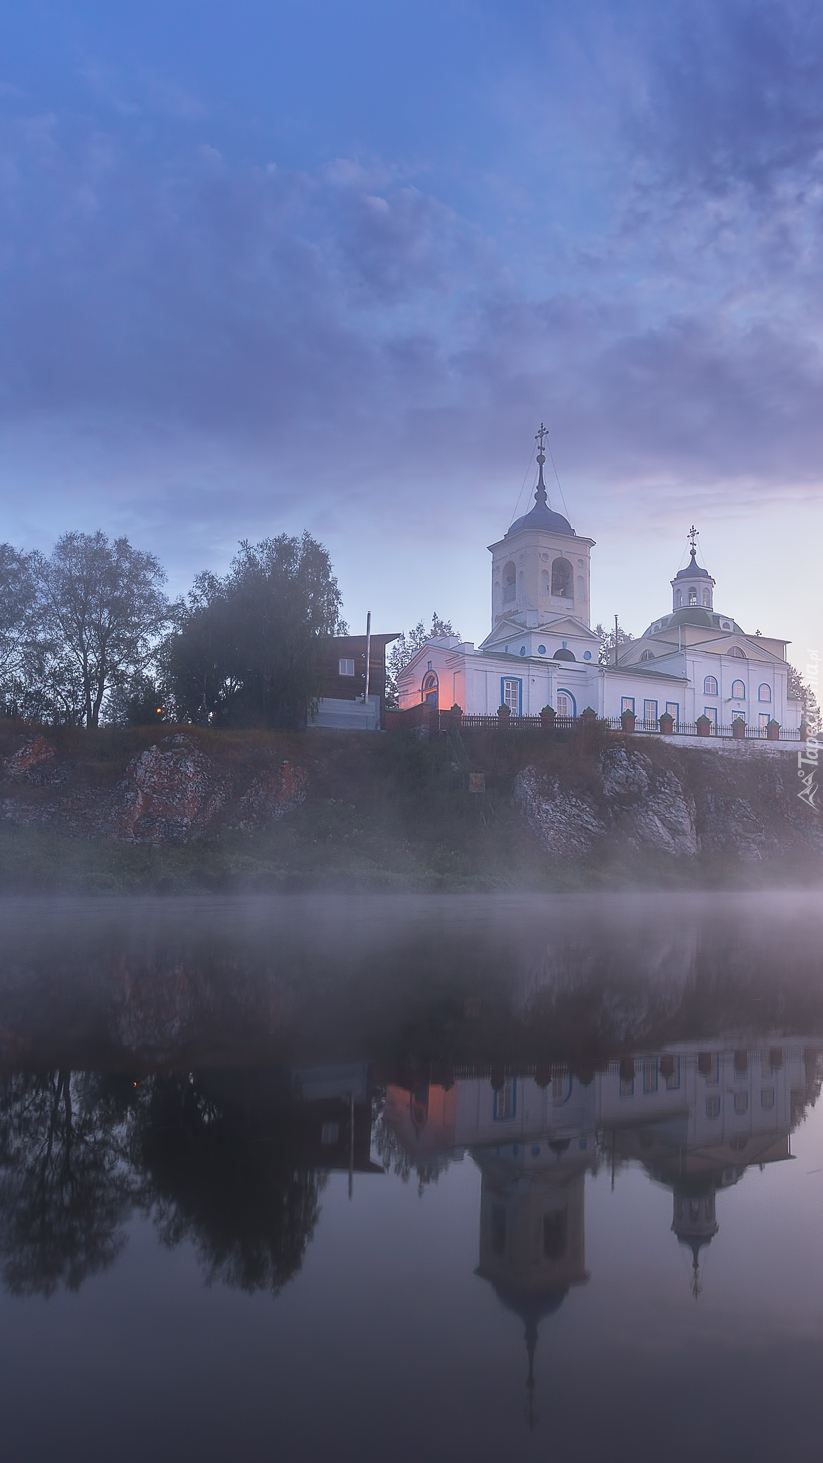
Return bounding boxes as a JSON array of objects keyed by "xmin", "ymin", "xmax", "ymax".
[{"xmin": 165, "ymin": 534, "xmax": 345, "ymax": 726}]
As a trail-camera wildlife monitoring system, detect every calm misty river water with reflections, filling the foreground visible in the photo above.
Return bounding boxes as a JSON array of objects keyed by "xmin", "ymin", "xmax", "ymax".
[{"xmin": 0, "ymin": 895, "xmax": 823, "ymax": 1463}]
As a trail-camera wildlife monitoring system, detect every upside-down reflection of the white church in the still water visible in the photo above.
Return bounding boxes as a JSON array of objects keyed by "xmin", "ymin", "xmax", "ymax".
[{"xmin": 384, "ymin": 1040, "xmax": 820, "ymax": 1413}]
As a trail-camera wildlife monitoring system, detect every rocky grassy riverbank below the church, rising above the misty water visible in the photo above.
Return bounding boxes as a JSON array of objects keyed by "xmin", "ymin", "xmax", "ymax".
[{"xmin": 0, "ymin": 723, "xmax": 823, "ymax": 892}]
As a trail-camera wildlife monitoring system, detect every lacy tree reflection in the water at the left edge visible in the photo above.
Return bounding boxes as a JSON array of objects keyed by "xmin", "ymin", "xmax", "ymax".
[{"xmin": 0, "ymin": 1072, "xmax": 134, "ymax": 1295}]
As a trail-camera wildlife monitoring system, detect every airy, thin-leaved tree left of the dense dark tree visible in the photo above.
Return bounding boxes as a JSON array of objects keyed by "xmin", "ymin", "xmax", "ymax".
[{"xmin": 32, "ymin": 531, "xmax": 168, "ymax": 727}]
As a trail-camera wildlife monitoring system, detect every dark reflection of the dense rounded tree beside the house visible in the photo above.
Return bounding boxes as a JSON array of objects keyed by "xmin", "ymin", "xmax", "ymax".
[{"xmin": 134, "ymin": 1075, "xmax": 322, "ymax": 1293}]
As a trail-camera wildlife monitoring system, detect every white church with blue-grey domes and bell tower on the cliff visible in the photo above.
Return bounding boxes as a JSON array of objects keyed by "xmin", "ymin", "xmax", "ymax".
[{"xmin": 398, "ymin": 427, "xmax": 801, "ymax": 739}]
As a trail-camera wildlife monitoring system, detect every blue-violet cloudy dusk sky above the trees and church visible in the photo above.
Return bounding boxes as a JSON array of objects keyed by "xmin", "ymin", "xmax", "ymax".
[{"xmin": 0, "ymin": 0, "xmax": 823, "ymax": 666}]
